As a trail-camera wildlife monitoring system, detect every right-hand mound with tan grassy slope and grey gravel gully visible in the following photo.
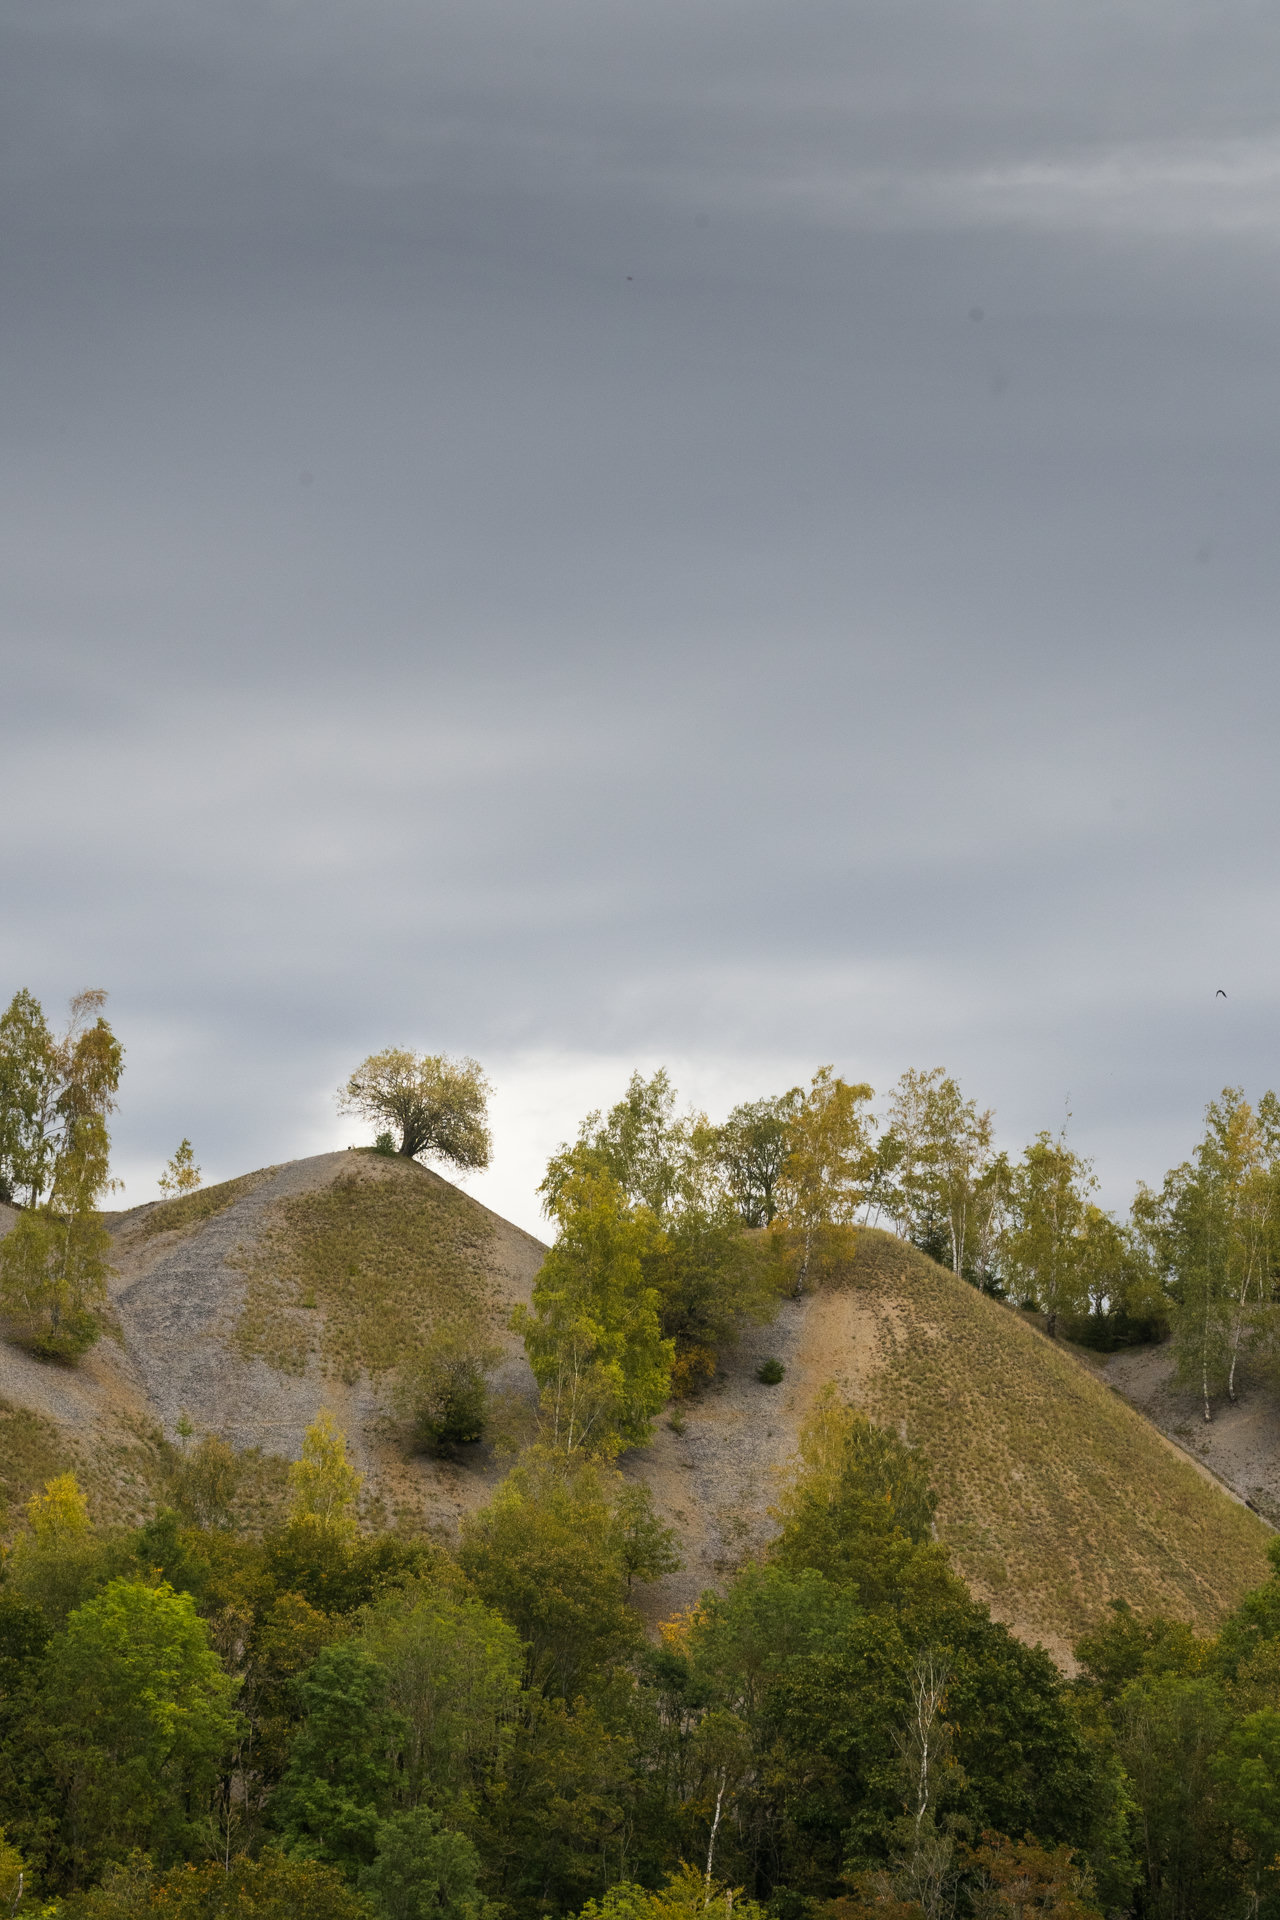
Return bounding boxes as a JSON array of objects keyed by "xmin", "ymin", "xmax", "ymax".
[{"xmin": 629, "ymin": 1229, "xmax": 1268, "ymax": 1661}]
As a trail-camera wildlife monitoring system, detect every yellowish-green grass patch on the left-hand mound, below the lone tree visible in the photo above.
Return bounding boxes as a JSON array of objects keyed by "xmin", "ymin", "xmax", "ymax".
[{"xmin": 236, "ymin": 1156, "xmax": 491, "ymax": 1380}]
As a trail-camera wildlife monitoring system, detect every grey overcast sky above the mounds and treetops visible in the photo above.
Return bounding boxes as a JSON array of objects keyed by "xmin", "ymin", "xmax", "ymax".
[{"xmin": 0, "ymin": 0, "xmax": 1280, "ymax": 1227}]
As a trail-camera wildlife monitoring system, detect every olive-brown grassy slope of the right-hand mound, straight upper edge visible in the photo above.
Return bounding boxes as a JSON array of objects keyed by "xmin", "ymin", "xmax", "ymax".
[{"xmin": 850, "ymin": 1231, "xmax": 1270, "ymax": 1644}]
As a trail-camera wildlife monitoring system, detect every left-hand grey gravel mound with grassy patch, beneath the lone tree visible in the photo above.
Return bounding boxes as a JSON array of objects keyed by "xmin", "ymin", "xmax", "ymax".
[{"xmin": 0, "ymin": 1152, "xmax": 545, "ymax": 1523}]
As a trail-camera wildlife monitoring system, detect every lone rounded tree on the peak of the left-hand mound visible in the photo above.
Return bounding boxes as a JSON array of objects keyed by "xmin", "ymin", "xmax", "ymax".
[{"xmin": 338, "ymin": 1046, "xmax": 493, "ymax": 1169}]
